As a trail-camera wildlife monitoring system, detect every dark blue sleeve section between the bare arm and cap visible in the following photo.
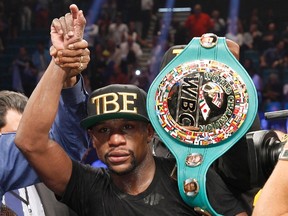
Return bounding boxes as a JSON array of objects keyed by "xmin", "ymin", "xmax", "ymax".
[{"xmin": 50, "ymin": 76, "xmax": 90, "ymax": 161}]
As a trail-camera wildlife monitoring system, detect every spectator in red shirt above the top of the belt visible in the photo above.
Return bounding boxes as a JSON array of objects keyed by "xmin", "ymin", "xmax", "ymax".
[{"xmin": 185, "ymin": 4, "xmax": 214, "ymax": 39}]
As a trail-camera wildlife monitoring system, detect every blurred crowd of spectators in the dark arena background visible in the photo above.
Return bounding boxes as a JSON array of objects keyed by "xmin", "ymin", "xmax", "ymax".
[{"xmin": 0, "ymin": 0, "xmax": 288, "ymax": 130}]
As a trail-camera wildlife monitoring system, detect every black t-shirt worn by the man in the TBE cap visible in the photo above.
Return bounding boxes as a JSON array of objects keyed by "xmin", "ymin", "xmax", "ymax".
[{"xmin": 62, "ymin": 157, "xmax": 243, "ymax": 216}]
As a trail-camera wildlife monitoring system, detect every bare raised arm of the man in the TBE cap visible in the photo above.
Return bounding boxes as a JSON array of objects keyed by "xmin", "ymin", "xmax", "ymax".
[{"xmin": 15, "ymin": 3, "xmax": 85, "ymax": 195}]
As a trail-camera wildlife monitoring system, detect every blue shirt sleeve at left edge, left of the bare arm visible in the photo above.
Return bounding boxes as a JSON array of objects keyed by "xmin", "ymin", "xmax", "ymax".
[{"xmin": 0, "ymin": 133, "xmax": 39, "ymax": 198}]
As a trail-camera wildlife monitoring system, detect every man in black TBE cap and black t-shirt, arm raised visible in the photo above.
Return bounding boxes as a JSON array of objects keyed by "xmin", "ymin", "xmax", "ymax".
[{"xmin": 15, "ymin": 6, "xmax": 247, "ymax": 215}]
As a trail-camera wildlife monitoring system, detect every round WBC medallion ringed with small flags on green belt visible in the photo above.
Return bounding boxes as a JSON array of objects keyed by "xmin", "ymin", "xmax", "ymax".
[{"xmin": 155, "ymin": 60, "xmax": 248, "ymax": 146}]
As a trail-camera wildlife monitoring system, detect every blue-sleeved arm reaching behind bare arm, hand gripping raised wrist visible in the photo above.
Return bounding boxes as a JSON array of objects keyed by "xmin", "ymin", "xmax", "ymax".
[{"xmin": 0, "ymin": 5, "xmax": 90, "ymax": 198}]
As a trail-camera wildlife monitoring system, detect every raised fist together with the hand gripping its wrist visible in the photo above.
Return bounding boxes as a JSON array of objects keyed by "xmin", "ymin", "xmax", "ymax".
[{"xmin": 50, "ymin": 4, "xmax": 90, "ymax": 82}]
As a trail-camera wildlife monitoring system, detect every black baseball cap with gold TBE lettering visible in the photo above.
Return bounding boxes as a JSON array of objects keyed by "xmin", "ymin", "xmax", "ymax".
[{"xmin": 81, "ymin": 84, "xmax": 149, "ymax": 129}]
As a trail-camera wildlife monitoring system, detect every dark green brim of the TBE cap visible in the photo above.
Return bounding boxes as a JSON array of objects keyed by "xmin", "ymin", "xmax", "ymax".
[{"xmin": 80, "ymin": 113, "xmax": 149, "ymax": 129}]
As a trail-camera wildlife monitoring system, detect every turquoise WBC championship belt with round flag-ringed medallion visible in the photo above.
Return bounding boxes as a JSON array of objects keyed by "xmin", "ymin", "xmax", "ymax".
[{"xmin": 147, "ymin": 33, "xmax": 258, "ymax": 215}]
